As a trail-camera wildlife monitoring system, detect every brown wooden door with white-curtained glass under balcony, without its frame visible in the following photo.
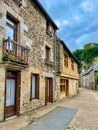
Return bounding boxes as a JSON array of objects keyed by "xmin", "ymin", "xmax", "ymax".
[{"xmin": 5, "ymin": 78, "xmax": 16, "ymax": 117}]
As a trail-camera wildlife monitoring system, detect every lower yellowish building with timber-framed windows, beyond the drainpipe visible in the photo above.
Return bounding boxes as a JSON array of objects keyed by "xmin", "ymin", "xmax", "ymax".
[{"xmin": 56, "ymin": 37, "xmax": 79, "ymax": 99}]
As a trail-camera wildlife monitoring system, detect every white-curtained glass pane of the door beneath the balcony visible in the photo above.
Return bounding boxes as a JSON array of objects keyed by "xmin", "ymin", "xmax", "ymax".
[{"xmin": 6, "ymin": 79, "xmax": 15, "ymax": 106}]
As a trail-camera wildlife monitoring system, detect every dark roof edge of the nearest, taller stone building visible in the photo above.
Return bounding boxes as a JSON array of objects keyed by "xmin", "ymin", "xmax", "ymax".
[{"xmin": 32, "ymin": 0, "xmax": 59, "ymax": 30}]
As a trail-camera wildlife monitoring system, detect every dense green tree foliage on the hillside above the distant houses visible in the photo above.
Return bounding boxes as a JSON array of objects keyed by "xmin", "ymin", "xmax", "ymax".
[{"xmin": 73, "ymin": 42, "xmax": 98, "ymax": 65}]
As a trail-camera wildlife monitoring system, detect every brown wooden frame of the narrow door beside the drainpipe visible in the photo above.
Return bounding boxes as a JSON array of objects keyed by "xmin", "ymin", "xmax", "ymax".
[{"xmin": 45, "ymin": 77, "xmax": 53, "ymax": 105}]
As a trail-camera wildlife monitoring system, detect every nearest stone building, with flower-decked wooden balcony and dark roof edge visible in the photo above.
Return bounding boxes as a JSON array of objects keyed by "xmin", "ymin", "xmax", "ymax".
[{"xmin": 0, "ymin": 0, "xmax": 58, "ymax": 121}]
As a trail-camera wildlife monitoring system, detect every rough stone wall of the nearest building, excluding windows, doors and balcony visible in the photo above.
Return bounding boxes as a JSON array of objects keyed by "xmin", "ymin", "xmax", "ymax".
[{"xmin": 0, "ymin": 0, "xmax": 57, "ymax": 121}]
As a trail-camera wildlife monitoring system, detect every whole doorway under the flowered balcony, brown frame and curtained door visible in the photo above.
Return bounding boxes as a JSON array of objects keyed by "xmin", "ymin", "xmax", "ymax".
[{"xmin": 5, "ymin": 70, "xmax": 21, "ymax": 118}]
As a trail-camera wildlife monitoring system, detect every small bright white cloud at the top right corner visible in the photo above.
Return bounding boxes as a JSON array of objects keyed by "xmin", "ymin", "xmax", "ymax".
[{"xmin": 81, "ymin": 0, "xmax": 94, "ymax": 12}]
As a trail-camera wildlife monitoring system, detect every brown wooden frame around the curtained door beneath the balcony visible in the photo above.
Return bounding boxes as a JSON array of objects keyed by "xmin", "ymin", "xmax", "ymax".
[{"xmin": 4, "ymin": 69, "xmax": 21, "ymax": 120}]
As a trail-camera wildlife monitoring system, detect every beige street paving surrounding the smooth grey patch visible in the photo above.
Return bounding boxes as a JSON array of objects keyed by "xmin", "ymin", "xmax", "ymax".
[{"xmin": 0, "ymin": 88, "xmax": 98, "ymax": 130}]
